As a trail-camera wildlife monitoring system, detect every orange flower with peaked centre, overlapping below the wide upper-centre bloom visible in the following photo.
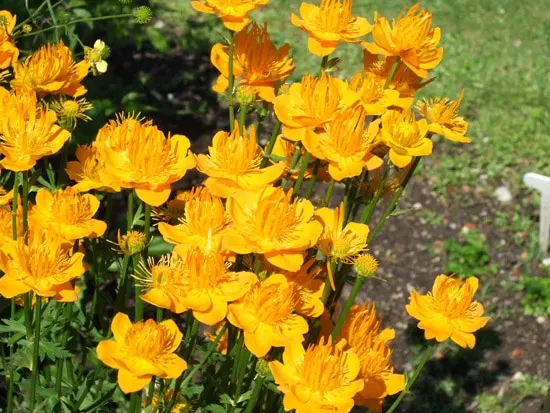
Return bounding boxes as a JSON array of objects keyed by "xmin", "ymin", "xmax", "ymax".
[{"xmin": 303, "ymin": 106, "xmax": 383, "ymax": 181}]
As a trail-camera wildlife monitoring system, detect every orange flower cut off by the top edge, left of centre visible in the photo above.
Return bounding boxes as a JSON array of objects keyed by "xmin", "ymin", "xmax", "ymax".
[{"xmin": 191, "ymin": 0, "xmax": 269, "ymax": 32}]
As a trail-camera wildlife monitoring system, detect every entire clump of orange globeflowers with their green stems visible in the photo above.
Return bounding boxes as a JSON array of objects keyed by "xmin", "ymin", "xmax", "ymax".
[{"xmin": 0, "ymin": 0, "xmax": 489, "ymax": 413}]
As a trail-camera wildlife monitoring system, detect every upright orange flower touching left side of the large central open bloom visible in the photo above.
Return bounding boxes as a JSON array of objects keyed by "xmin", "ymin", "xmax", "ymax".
[{"xmin": 159, "ymin": 187, "xmax": 231, "ymax": 251}]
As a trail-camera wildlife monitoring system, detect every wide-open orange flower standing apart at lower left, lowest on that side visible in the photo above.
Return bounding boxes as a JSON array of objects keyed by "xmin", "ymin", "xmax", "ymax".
[{"xmin": 97, "ymin": 313, "xmax": 187, "ymax": 393}]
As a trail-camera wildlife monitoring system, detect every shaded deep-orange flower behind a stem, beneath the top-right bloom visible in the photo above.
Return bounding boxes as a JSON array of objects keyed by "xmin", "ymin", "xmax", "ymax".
[{"xmin": 363, "ymin": 50, "xmax": 434, "ymax": 109}]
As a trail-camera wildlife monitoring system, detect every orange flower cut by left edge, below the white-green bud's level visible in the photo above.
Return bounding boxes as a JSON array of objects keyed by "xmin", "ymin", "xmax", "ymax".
[{"xmin": 0, "ymin": 88, "xmax": 71, "ymax": 172}]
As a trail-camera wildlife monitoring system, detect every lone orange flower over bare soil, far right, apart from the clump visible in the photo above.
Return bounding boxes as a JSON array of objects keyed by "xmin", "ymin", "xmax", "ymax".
[{"xmin": 406, "ymin": 274, "xmax": 490, "ymax": 348}]
